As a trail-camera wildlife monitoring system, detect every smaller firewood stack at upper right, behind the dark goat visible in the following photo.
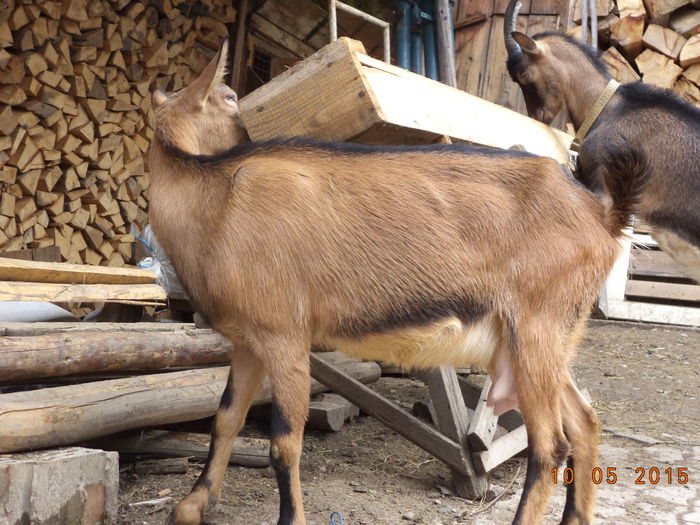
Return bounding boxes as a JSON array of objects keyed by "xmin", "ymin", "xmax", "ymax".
[{"xmin": 572, "ymin": 0, "xmax": 700, "ymax": 105}]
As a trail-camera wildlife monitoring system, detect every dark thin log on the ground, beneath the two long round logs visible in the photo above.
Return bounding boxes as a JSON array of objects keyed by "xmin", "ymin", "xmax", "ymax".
[{"xmin": 87, "ymin": 430, "xmax": 270, "ymax": 468}]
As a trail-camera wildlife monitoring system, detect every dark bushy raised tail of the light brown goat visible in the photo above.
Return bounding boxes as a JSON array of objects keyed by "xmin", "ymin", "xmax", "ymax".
[{"xmin": 599, "ymin": 139, "xmax": 649, "ymax": 236}]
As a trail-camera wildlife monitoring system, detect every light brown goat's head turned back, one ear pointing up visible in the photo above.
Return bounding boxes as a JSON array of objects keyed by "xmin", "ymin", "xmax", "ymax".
[{"xmin": 153, "ymin": 39, "xmax": 248, "ymax": 155}]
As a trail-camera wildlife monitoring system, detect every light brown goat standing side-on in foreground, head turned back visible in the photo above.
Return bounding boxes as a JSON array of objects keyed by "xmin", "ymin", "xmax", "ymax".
[{"xmin": 149, "ymin": 39, "xmax": 623, "ymax": 525}]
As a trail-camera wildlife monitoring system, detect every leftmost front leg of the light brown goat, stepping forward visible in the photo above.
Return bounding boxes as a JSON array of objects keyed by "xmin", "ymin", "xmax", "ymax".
[{"xmin": 169, "ymin": 344, "xmax": 265, "ymax": 525}]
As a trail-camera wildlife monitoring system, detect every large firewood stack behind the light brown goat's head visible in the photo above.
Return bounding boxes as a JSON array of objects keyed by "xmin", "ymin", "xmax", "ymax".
[{"xmin": 0, "ymin": 0, "xmax": 236, "ymax": 266}]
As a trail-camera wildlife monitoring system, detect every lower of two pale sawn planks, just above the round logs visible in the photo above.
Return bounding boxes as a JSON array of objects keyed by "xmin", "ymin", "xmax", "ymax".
[{"xmin": 0, "ymin": 281, "xmax": 166, "ymax": 304}]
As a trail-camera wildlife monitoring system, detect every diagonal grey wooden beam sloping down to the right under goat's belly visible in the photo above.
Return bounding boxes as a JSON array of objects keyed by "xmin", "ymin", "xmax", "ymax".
[{"xmin": 308, "ymin": 353, "xmax": 472, "ymax": 475}]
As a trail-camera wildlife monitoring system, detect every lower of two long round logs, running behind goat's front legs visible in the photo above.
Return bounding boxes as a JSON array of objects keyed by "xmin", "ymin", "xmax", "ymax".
[{"xmin": 0, "ymin": 354, "xmax": 380, "ymax": 453}]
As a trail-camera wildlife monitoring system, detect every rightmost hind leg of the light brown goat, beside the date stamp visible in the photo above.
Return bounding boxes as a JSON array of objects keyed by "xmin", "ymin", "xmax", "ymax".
[{"xmin": 561, "ymin": 375, "xmax": 598, "ymax": 525}]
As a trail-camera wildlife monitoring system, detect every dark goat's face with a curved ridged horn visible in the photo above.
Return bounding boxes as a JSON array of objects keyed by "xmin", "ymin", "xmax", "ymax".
[{"xmin": 503, "ymin": 0, "xmax": 564, "ymax": 124}]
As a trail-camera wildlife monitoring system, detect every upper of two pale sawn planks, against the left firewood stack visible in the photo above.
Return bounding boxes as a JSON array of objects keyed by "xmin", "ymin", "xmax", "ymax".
[{"xmin": 0, "ymin": 257, "xmax": 156, "ymax": 284}]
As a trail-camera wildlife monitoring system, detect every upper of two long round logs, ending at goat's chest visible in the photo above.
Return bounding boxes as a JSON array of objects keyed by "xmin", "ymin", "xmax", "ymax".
[{"xmin": 0, "ymin": 326, "xmax": 232, "ymax": 383}]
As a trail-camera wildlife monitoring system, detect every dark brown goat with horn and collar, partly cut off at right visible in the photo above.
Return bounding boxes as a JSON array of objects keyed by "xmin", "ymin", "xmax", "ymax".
[{"xmin": 504, "ymin": 0, "xmax": 700, "ymax": 282}]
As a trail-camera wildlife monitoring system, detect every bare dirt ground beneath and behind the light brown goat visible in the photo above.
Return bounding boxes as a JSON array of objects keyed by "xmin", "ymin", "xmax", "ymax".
[{"xmin": 119, "ymin": 321, "xmax": 700, "ymax": 525}]
